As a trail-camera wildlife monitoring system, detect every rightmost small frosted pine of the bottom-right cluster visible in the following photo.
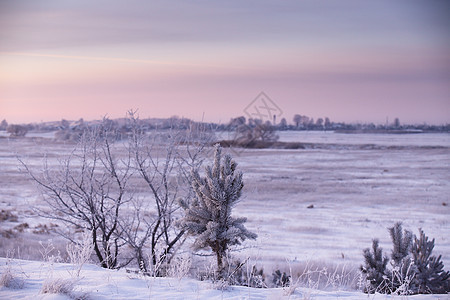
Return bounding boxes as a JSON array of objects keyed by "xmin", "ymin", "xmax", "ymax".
[{"xmin": 411, "ymin": 229, "xmax": 450, "ymax": 294}]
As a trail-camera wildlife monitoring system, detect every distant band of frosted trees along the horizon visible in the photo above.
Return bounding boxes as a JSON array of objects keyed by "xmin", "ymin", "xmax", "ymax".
[{"xmin": 0, "ymin": 114, "xmax": 450, "ymax": 142}]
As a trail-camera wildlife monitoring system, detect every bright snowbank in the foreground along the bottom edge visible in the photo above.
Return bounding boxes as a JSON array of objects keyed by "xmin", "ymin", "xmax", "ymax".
[{"xmin": 0, "ymin": 258, "xmax": 449, "ymax": 300}]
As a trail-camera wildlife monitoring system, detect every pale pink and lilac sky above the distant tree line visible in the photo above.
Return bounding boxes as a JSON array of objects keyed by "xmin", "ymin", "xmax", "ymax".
[{"xmin": 0, "ymin": 0, "xmax": 450, "ymax": 124}]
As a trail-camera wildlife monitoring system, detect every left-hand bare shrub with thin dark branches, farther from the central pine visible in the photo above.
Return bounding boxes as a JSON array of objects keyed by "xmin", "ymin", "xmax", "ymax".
[{"xmin": 20, "ymin": 120, "xmax": 131, "ymax": 268}]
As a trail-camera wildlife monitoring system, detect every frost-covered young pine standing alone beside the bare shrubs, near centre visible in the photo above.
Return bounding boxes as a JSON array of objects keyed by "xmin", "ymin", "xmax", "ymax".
[{"xmin": 181, "ymin": 144, "xmax": 256, "ymax": 279}]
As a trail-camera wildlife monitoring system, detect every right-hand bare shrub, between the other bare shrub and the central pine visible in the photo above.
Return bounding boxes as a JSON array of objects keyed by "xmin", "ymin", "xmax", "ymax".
[{"xmin": 122, "ymin": 112, "xmax": 209, "ymax": 276}]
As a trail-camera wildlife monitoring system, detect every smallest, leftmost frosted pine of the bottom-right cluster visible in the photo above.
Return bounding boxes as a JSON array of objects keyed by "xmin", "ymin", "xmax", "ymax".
[{"xmin": 360, "ymin": 239, "xmax": 389, "ymax": 293}]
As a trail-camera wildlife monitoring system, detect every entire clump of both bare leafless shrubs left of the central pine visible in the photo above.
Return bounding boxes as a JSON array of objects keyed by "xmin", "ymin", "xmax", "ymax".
[{"xmin": 18, "ymin": 112, "xmax": 210, "ymax": 275}]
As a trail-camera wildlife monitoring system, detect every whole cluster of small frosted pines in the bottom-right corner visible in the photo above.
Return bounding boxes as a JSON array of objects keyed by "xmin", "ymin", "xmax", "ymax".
[{"xmin": 361, "ymin": 223, "xmax": 450, "ymax": 295}]
